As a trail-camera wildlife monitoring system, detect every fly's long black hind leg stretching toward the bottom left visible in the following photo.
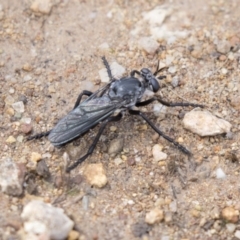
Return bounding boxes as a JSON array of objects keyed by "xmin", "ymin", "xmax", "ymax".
[{"xmin": 66, "ymin": 113, "xmax": 122, "ymax": 173}]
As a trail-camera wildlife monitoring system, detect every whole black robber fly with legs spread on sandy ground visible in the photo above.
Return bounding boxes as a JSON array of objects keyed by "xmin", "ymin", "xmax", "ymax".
[{"xmin": 27, "ymin": 57, "xmax": 203, "ymax": 172}]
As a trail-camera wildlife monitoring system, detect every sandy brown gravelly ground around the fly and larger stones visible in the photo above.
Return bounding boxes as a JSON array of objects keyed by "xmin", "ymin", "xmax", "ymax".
[{"xmin": 0, "ymin": 0, "xmax": 240, "ymax": 240}]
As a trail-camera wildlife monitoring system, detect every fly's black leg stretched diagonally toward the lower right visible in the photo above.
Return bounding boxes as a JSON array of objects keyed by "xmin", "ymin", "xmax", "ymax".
[{"xmin": 129, "ymin": 110, "xmax": 191, "ymax": 155}]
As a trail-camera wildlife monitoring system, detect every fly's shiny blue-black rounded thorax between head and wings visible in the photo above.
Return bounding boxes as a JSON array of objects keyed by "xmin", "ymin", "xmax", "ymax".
[{"xmin": 108, "ymin": 77, "xmax": 145, "ymax": 107}]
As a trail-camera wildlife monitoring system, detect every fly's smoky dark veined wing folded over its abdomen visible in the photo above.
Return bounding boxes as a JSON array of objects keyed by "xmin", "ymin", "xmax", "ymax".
[{"xmin": 48, "ymin": 97, "xmax": 118, "ymax": 146}]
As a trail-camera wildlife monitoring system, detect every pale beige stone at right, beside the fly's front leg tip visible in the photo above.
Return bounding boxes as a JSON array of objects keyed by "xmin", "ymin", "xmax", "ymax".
[{"xmin": 183, "ymin": 110, "xmax": 232, "ymax": 137}]
